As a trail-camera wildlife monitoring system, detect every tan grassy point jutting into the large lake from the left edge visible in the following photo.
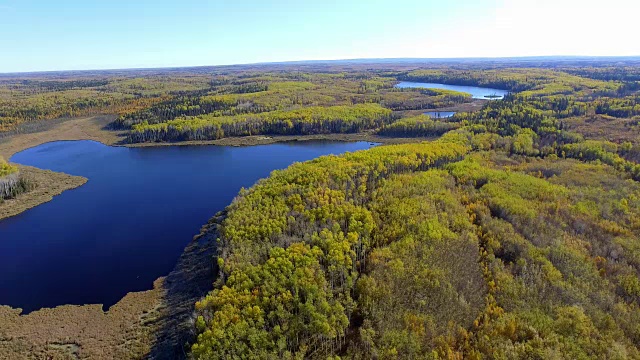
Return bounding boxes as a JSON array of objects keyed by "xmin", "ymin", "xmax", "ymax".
[{"xmin": 0, "ymin": 165, "xmax": 87, "ymax": 220}]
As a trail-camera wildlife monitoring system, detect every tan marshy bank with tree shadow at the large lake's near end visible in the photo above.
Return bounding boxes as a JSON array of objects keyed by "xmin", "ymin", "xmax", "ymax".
[{"xmin": 0, "ymin": 213, "xmax": 224, "ymax": 360}]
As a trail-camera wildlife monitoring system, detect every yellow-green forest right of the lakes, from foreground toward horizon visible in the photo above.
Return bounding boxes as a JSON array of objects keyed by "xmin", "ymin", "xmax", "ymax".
[{"xmin": 181, "ymin": 64, "xmax": 640, "ymax": 359}]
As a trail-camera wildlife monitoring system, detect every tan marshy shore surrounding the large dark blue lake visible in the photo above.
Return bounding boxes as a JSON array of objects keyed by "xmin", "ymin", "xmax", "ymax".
[{"xmin": 0, "ymin": 116, "xmax": 433, "ymax": 359}]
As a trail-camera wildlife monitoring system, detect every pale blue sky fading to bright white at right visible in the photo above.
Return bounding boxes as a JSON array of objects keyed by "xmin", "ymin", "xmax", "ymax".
[{"xmin": 0, "ymin": 0, "xmax": 640, "ymax": 73}]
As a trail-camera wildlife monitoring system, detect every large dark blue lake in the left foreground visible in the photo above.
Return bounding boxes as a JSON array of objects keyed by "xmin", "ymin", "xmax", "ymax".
[{"xmin": 0, "ymin": 141, "xmax": 373, "ymax": 312}]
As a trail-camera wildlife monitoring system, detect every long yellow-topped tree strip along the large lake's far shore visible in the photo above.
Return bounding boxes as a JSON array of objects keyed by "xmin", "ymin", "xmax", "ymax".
[{"xmin": 129, "ymin": 104, "xmax": 394, "ymax": 142}]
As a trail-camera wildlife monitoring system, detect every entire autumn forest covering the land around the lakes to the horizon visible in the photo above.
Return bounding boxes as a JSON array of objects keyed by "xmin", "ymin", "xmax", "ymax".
[{"xmin": 0, "ymin": 63, "xmax": 640, "ymax": 360}]
